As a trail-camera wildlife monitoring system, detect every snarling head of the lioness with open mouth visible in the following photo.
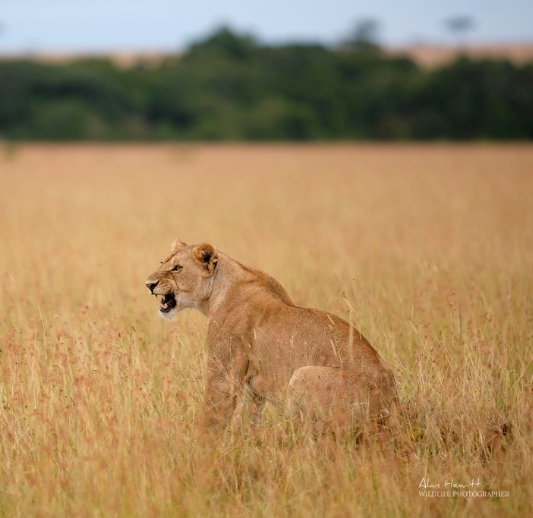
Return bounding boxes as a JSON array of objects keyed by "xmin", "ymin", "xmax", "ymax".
[{"xmin": 146, "ymin": 239, "xmax": 218, "ymax": 320}]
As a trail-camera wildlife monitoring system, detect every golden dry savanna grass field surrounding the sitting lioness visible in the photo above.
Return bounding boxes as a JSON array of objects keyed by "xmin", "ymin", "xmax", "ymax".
[{"xmin": 0, "ymin": 143, "xmax": 533, "ymax": 518}]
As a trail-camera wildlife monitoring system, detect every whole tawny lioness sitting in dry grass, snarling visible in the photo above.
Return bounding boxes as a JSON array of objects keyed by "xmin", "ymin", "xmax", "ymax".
[{"xmin": 146, "ymin": 239, "xmax": 396, "ymax": 434}]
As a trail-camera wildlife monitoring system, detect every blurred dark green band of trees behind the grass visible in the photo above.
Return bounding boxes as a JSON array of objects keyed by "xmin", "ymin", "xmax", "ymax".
[{"xmin": 0, "ymin": 28, "xmax": 533, "ymax": 141}]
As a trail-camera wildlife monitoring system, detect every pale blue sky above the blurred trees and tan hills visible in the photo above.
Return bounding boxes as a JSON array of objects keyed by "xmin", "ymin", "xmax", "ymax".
[{"xmin": 0, "ymin": 0, "xmax": 533, "ymax": 53}]
